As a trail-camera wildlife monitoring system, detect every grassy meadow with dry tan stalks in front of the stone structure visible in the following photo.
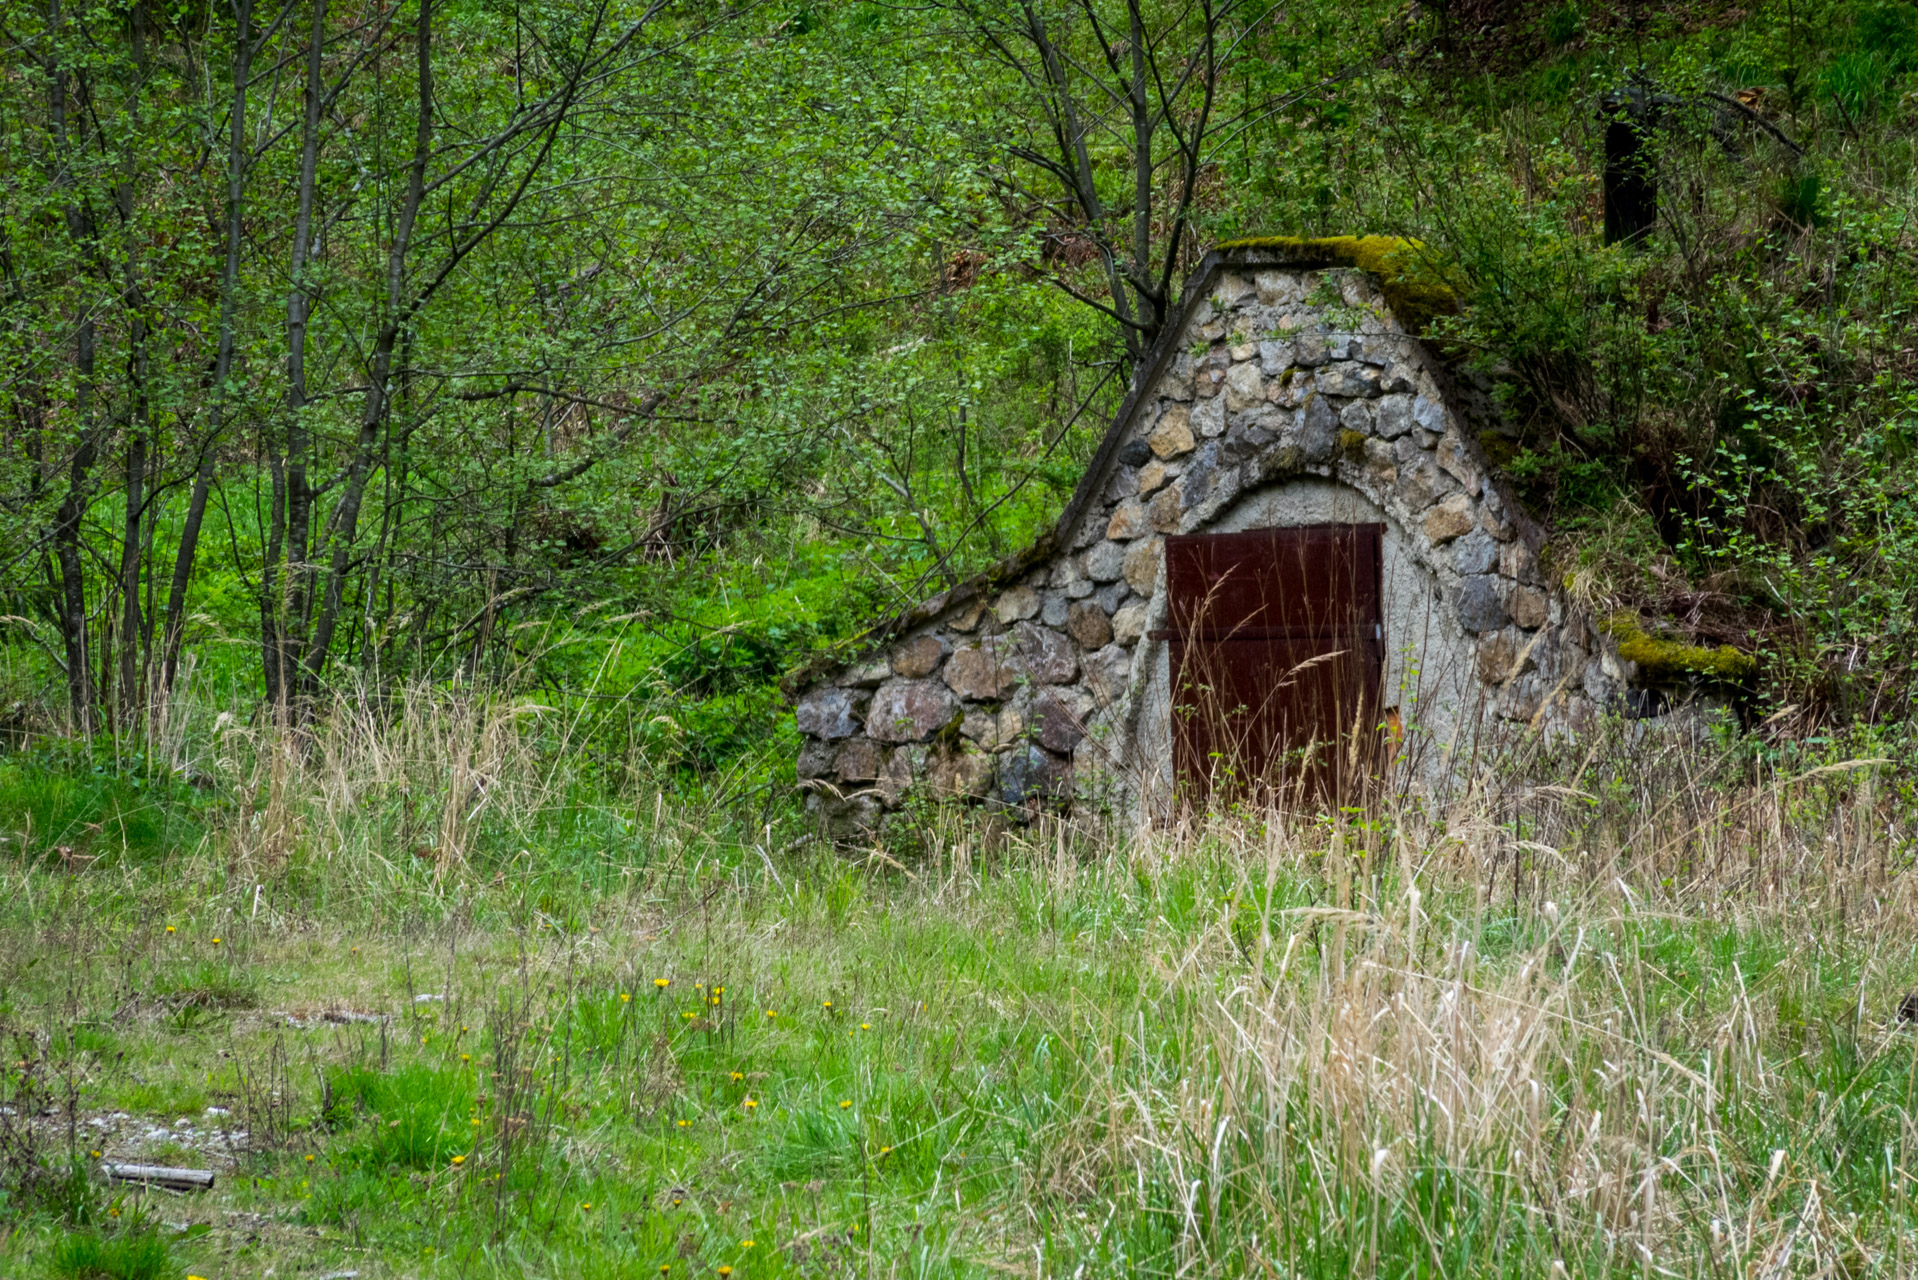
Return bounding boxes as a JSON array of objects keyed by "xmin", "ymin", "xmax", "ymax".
[{"xmin": 0, "ymin": 695, "xmax": 1918, "ymax": 1280}]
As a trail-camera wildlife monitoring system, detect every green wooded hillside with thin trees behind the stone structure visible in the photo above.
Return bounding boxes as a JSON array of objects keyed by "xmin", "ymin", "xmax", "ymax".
[{"xmin": 0, "ymin": 0, "xmax": 1918, "ymax": 789}]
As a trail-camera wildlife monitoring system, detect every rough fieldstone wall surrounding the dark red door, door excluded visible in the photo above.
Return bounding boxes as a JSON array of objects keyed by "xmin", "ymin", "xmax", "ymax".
[{"xmin": 798, "ymin": 259, "xmax": 1630, "ymax": 829}]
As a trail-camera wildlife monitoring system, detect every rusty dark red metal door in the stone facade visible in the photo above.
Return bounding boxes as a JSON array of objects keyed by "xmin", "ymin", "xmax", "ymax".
[{"xmin": 1158, "ymin": 524, "xmax": 1385, "ymax": 804}]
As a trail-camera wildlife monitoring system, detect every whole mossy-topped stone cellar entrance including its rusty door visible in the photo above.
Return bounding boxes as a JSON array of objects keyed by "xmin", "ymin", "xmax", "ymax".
[{"xmin": 788, "ymin": 236, "xmax": 1695, "ymax": 833}]
